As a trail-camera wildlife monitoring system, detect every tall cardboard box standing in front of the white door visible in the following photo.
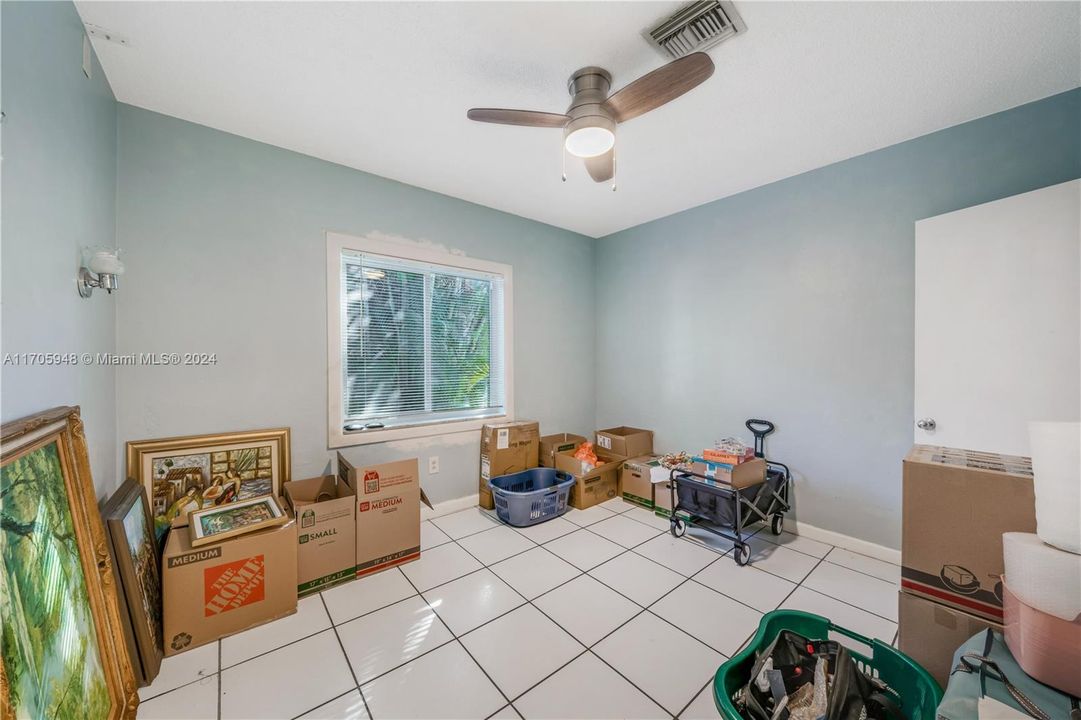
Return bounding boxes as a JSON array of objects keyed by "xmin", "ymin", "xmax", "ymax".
[{"xmin": 900, "ymin": 445, "xmax": 1036, "ymax": 623}]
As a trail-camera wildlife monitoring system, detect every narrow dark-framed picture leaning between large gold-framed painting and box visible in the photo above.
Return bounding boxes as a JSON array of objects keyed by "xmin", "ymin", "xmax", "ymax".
[{"xmin": 102, "ymin": 478, "xmax": 162, "ymax": 685}]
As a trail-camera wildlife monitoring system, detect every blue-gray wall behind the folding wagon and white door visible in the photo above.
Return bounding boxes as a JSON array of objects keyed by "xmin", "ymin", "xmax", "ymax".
[{"xmin": 596, "ymin": 90, "xmax": 1081, "ymax": 548}]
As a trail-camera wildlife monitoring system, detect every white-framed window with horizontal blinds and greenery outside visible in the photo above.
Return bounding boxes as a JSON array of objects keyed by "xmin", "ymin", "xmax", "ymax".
[{"xmin": 328, "ymin": 234, "xmax": 510, "ymax": 446}]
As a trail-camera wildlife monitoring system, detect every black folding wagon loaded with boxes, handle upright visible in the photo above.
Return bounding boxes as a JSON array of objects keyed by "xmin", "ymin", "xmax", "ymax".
[{"xmin": 665, "ymin": 419, "xmax": 791, "ymax": 565}]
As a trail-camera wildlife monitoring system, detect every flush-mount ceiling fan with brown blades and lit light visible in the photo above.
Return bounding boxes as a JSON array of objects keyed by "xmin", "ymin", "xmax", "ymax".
[{"xmin": 466, "ymin": 53, "xmax": 713, "ymax": 183}]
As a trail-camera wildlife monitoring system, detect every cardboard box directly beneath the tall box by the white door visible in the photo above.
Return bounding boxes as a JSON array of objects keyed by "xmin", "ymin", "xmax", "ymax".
[{"xmin": 897, "ymin": 590, "xmax": 1002, "ymax": 688}]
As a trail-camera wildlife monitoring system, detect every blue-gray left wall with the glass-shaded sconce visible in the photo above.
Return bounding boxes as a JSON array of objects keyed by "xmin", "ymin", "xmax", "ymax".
[{"xmin": 0, "ymin": 2, "xmax": 119, "ymax": 495}]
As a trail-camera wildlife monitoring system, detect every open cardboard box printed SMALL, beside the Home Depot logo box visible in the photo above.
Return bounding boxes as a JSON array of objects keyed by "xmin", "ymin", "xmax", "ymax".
[{"xmin": 282, "ymin": 475, "xmax": 357, "ymax": 596}]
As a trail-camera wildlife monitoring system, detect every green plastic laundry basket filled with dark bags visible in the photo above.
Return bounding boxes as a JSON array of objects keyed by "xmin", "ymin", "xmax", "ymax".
[{"xmin": 713, "ymin": 610, "xmax": 942, "ymax": 720}]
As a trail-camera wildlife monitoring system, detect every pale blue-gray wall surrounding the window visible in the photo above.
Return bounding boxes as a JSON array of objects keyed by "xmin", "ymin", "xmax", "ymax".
[{"xmin": 118, "ymin": 105, "xmax": 595, "ymax": 502}]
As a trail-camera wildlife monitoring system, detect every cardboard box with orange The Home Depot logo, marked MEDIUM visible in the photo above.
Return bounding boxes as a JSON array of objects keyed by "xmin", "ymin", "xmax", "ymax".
[{"xmin": 161, "ymin": 512, "xmax": 296, "ymax": 657}]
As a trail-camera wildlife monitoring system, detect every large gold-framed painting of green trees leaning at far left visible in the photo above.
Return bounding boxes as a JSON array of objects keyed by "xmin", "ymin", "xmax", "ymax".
[{"xmin": 0, "ymin": 408, "xmax": 138, "ymax": 720}]
